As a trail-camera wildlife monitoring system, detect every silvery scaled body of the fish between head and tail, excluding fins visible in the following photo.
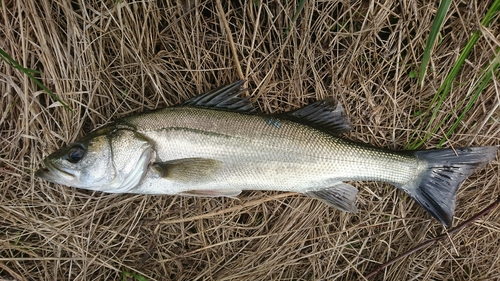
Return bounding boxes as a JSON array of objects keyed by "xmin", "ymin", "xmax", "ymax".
[{"xmin": 124, "ymin": 108, "xmax": 425, "ymax": 194}]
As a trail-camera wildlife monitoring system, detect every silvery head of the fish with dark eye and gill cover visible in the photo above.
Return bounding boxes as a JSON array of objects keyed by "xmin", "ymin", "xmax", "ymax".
[{"xmin": 35, "ymin": 126, "xmax": 154, "ymax": 193}]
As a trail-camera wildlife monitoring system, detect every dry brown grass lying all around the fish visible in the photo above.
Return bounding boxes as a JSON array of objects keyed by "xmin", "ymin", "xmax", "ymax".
[{"xmin": 0, "ymin": 0, "xmax": 500, "ymax": 280}]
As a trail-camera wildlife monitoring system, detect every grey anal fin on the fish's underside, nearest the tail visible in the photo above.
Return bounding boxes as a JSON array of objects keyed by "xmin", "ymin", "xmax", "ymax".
[{"xmin": 305, "ymin": 182, "xmax": 358, "ymax": 213}]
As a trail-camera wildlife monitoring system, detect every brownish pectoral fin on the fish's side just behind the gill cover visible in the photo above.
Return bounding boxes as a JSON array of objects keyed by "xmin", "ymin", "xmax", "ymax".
[{"xmin": 152, "ymin": 158, "xmax": 222, "ymax": 182}]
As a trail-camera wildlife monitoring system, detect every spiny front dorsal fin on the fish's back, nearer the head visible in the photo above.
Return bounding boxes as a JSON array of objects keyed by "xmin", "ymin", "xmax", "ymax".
[{"xmin": 182, "ymin": 80, "xmax": 255, "ymax": 113}]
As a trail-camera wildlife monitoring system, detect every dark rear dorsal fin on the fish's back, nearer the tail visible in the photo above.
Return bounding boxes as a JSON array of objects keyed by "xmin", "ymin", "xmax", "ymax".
[{"xmin": 280, "ymin": 98, "xmax": 351, "ymax": 135}]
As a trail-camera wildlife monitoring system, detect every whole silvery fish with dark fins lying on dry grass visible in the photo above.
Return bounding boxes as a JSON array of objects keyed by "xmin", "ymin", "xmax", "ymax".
[{"xmin": 35, "ymin": 81, "xmax": 498, "ymax": 224}]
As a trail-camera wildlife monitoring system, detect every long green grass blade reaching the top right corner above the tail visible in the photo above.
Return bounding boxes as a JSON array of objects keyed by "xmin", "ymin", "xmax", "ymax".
[{"xmin": 406, "ymin": 0, "xmax": 500, "ymax": 149}]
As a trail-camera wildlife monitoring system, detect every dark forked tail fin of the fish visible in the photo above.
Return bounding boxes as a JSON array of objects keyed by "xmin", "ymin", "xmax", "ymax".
[{"xmin": 401, "ymin": 146, "xmax": 498, "ymax": 227}]
